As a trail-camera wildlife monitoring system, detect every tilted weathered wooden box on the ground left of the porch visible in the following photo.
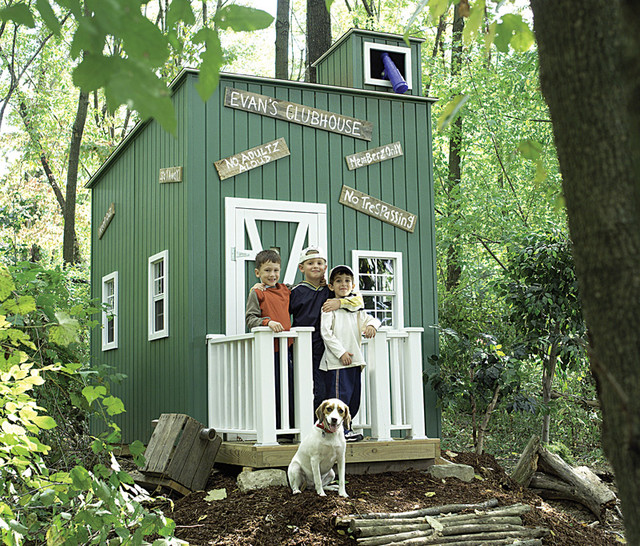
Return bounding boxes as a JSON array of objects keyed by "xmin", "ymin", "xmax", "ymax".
[{"xmin": 142, "ymin": 413, "xmax": 222, "ymax": 494}]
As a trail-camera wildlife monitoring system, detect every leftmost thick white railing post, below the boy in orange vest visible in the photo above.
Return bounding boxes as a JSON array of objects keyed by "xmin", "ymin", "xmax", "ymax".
[{"xmin": 251, "ymin": 326, "xmax": 278, "ymax": 445}]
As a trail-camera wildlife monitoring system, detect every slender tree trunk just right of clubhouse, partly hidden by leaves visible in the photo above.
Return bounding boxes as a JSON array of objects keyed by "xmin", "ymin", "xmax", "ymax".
[{"xmin": 445, "ymin": 4, "xmax": 464, "ymax": 292}]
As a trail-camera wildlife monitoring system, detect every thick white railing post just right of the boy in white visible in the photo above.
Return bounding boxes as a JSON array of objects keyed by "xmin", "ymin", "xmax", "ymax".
[{"xmin": 368, "ymin": 327, "xmax": 391, "ymax": 441}]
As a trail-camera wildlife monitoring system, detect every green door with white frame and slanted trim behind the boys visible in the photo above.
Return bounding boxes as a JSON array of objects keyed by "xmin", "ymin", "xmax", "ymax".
[{"xmin": 225, "ymin": 197, "xmax": 327, "ymax": 335}]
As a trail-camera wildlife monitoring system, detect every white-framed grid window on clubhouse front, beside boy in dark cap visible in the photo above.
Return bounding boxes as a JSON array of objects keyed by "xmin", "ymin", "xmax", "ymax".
[{"xmin": 353, "ymin": 250, "xmax": 404, "ymax": 328}]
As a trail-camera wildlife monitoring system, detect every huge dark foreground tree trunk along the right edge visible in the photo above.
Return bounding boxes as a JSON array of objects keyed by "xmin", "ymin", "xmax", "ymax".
[{"xmin": 531, "ymin": 0, "xmax": 640, "ymax": 544}]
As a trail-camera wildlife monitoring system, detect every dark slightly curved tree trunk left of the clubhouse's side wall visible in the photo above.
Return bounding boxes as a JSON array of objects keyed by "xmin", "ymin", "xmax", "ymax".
[{"xmin": 62, "ymin": 91, "xmax": 89, "ymax": 264}]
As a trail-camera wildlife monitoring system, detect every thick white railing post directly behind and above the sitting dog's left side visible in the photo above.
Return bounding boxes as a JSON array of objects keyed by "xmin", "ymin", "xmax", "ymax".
[{"xmin": 291, "ymin": 326, "xmax": 315, "ymax": 439}]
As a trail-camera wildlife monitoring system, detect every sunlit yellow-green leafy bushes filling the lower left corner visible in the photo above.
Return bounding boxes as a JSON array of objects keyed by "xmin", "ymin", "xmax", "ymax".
[{"xmin": 0, "ymin": 264, "xmax": 177, "ymax": 545}]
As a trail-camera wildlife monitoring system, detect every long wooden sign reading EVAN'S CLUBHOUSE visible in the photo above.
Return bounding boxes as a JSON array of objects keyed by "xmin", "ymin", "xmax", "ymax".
[{"xmin": 224, "ymin": 87, "xmax": 373, "ymax": 140}]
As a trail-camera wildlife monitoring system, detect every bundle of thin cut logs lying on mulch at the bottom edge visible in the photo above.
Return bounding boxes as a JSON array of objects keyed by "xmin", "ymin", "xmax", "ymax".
[{"xmin": 335, "ymin": 499, "xmax": 549, "ymax": 546}]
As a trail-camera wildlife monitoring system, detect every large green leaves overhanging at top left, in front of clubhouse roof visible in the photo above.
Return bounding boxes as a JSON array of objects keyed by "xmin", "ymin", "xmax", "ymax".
[{"xmin": 0, "ymin": 0, "xmax": 273, "ymax": 132}]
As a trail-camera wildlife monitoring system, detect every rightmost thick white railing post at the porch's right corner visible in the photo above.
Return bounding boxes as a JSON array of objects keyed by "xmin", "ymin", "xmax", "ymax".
[{"xmin": 403, "ymin": 328, "xmax": 427, "ymax": 440}]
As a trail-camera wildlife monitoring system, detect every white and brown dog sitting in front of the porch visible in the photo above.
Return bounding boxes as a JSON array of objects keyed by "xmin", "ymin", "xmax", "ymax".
[{"xmin": 287, "ymin": 398, "xmax": 351, "ymax": 497}]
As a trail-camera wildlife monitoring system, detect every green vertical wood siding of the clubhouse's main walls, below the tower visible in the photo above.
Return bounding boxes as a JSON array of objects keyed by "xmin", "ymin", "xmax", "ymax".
[{"xmin": 91, "ymin": 68, "xmax": 440, "ymax": 442}]
